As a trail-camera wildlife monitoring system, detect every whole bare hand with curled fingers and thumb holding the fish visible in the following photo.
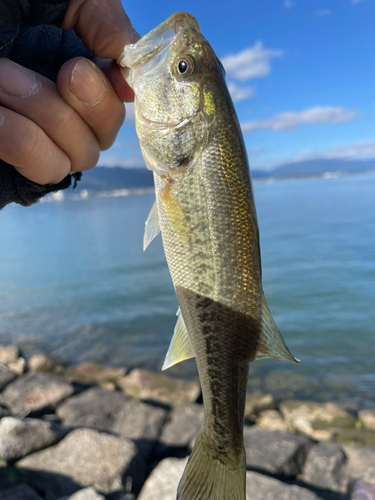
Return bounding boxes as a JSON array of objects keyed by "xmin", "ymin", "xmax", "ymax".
[{"xmin": 0, "ymin": 0, "xmax": 140, "ymax": 185}]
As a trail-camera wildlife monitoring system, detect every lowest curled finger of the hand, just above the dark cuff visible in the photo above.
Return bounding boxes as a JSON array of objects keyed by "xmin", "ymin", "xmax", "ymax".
[{"xmin": 0, "ymin": 106, "xmax": 71, "ymax": 185}]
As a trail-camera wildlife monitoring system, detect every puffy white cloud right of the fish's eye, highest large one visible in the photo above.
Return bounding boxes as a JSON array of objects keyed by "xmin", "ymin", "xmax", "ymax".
[{"xmin": 221, "ymin": 41, "xmax": 284, "ymax": 81}]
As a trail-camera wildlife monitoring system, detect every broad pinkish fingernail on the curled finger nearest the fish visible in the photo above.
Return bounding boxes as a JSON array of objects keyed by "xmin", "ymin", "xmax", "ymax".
[{"xmin": 70, "ymin": 59, "xmax": 107, "ymax": 106}]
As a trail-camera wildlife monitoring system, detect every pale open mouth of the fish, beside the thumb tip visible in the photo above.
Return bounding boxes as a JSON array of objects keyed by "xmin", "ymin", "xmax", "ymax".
[{"xmin": 117, "ymin": 12, "xmax": 201, "ymax": 74}]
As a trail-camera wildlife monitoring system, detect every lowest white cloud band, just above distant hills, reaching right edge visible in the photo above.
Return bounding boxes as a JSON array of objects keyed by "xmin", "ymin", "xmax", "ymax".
[{"xmin": 252, "ymin": 141, "xmax": 375, "ymax": 169}]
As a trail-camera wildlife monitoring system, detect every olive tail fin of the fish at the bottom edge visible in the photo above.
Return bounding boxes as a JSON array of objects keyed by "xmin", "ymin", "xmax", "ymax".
[{"xmin": 177, "ymin": 428, "xmax": 246, "ymax": 500}]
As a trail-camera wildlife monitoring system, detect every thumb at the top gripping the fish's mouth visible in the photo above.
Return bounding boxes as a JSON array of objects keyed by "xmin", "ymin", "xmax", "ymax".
[{"xmin": 61, "ymin": 0, "xmax": 141, "ymax": 60}]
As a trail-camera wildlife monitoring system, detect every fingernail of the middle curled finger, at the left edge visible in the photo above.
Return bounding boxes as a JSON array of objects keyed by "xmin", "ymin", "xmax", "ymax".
[{"xmin": 0, "ymin": 59, "xmax": 42, "ymax": 97}]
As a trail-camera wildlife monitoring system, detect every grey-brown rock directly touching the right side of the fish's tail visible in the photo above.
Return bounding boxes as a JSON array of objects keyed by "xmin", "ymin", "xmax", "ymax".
[{"xmin": 244, "ymin": 426, "xmax": 313, "ymax": 477}]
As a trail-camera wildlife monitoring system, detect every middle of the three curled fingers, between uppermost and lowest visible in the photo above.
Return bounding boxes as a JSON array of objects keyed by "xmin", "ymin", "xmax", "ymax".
[{"xmin": 0, "ymin": 59, "xmax": 100, "ymax": 172}]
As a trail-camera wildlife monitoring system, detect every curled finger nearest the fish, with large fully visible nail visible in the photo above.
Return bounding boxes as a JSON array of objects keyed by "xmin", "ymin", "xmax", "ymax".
[{"xmin": 57, "ymin": 57, "xmax": 125, "ymax": 150}]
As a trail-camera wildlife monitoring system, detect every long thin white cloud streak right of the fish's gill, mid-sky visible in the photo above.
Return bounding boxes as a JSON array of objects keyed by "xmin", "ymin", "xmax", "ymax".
[{"xmin": 241, "ymin": 106, "xmax": 358, "ymax": 134}]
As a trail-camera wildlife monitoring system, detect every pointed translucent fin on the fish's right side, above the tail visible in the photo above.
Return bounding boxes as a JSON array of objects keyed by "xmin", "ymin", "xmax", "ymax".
[{"xmin": 255, "ymin": 294, "xmax": 299, "ymax": 363}]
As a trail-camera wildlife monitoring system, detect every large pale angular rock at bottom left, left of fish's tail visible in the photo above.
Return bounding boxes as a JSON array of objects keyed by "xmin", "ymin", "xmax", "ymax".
[{"xmin": 17, "ymin": 429, "xmax": 146, "ymax": 499}]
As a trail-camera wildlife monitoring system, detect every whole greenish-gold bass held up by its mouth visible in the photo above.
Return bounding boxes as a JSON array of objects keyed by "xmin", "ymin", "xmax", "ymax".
[{"xmin": 118, "ymin": 12, "xmax": 298, "ymax": 500}]
